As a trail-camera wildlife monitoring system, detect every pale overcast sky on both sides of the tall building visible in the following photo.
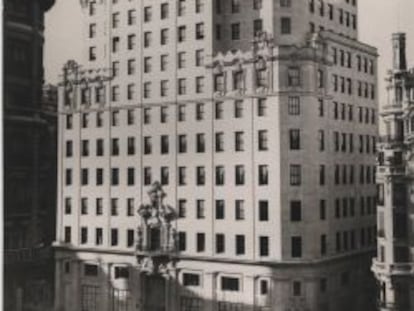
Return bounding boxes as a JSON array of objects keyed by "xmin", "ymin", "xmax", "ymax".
[{"xmin": 44, "ymin": 0, "xmax": 414, "ymax": 105}]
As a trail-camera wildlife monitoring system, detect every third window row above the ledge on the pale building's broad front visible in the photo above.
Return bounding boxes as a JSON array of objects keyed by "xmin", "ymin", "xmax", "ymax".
[{"xmin": 65, "ymin": 165, "xmax": 269, "ymax": 186}]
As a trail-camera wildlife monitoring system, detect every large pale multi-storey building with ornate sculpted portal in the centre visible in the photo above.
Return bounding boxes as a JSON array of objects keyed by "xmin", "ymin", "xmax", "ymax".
[{"xmin": 55, "ymin": 0, "xmax": 377, "ymax": 311}]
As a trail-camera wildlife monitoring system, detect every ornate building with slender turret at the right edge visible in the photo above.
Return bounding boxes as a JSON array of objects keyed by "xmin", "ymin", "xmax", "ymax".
[{"xmin": 372, "ymin": 33, "xmax": 414, "ymax": 311}]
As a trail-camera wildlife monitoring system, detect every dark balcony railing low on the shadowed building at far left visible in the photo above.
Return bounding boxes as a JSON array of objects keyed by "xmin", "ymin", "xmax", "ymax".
[{"xmin": 4, "ymin": 247, "xmax": 52, "ymax": 265}]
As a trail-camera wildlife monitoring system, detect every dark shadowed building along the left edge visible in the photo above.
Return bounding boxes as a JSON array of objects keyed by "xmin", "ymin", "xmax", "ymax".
[{"xmin": 3, "ymin": 0, "xmax": 57, "ymax": 310}]
